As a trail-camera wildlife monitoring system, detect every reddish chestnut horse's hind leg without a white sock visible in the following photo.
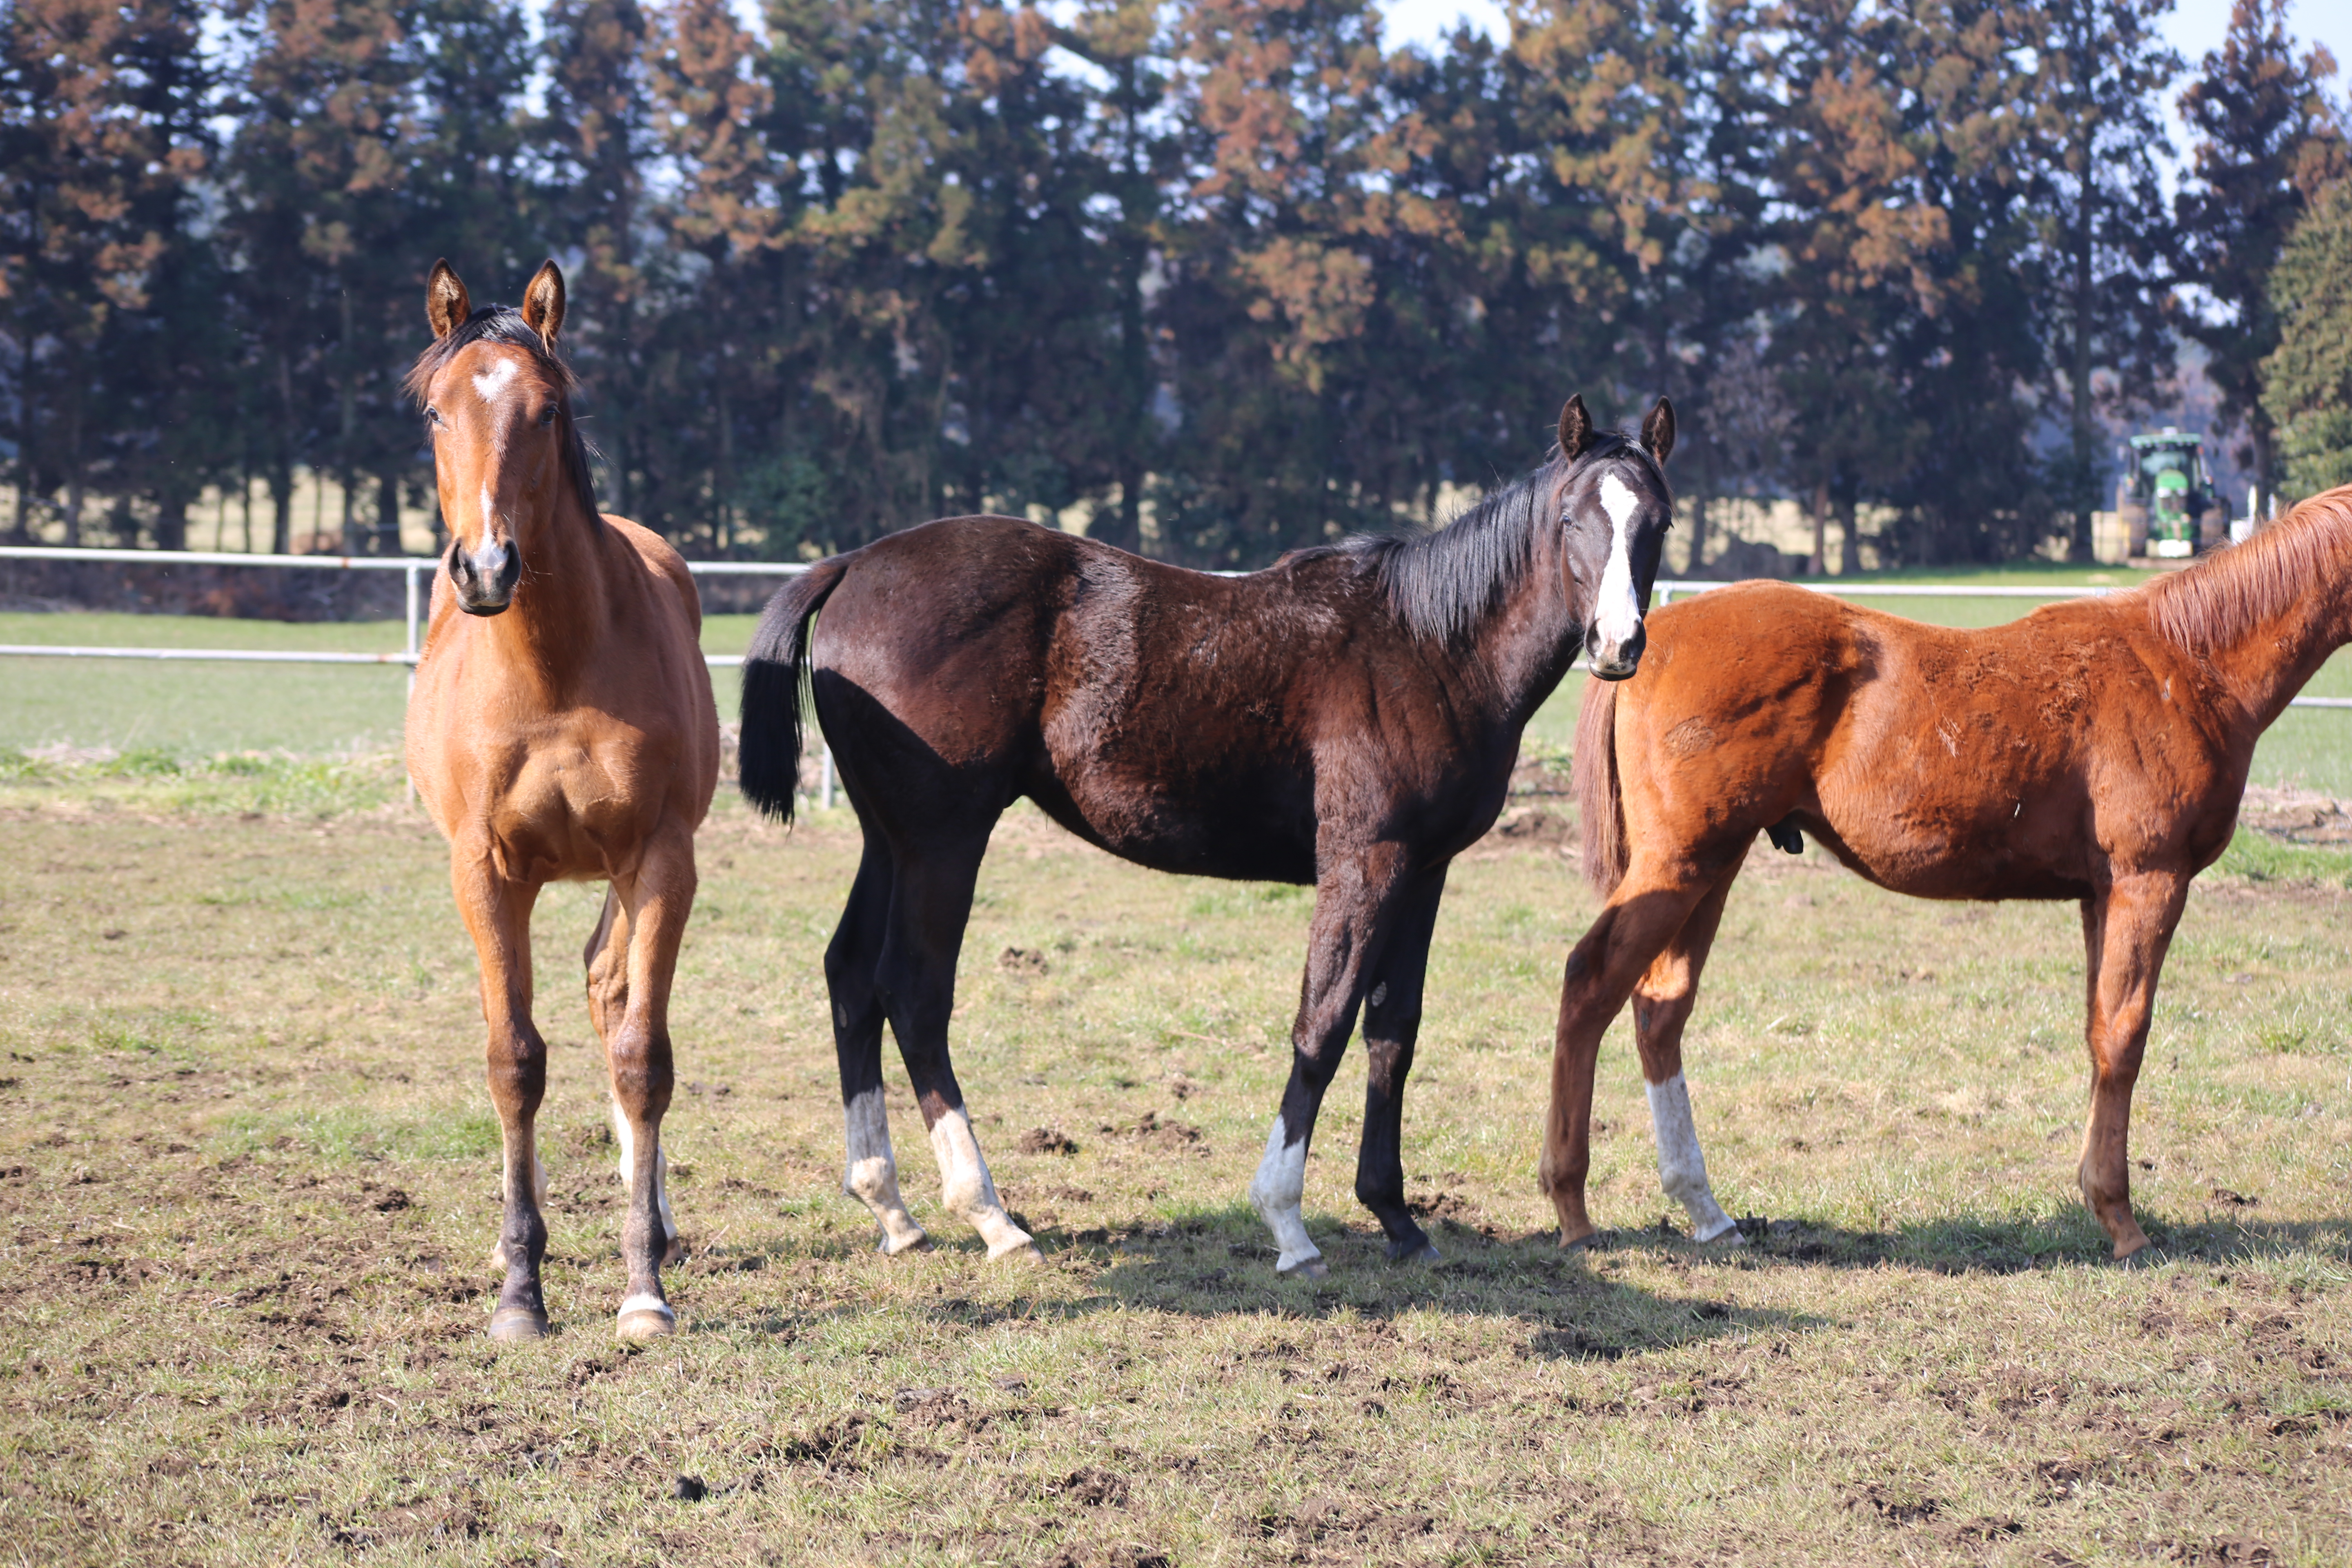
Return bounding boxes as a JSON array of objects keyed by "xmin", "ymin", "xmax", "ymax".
[{"xmin": 1536, "ymin": 865, "xmax": 1729, "ymax": 1246}]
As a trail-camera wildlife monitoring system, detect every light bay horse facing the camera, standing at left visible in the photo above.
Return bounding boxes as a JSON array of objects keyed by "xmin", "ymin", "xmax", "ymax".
[{"xmin": 407, "ymin": 261, "xmax": 720, "ymax": 1340}]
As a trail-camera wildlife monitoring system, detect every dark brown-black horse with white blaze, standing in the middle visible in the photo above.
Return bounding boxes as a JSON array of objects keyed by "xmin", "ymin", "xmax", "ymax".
[{"xmin": 743, "ymin": 397, "xmax": 1675, "ymax": 1276}]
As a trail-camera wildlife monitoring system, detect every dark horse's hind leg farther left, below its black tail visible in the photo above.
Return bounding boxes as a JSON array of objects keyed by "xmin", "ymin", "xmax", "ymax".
[{"xmin": 826, "ymin": 837, "xmax": 924, "ymax": 1253}]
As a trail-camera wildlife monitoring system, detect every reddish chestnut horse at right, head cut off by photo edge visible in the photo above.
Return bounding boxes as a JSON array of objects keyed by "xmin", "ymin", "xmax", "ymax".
[{"xmin": 1541, "ymin": 487, "xmax": 2352, "ymax": 1258}]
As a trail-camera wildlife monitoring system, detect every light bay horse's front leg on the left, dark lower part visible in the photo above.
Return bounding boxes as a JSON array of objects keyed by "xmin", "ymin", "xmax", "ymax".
[{"xmin": 449, "ymin": 839, "xmax": 548, "ymax": 1340}]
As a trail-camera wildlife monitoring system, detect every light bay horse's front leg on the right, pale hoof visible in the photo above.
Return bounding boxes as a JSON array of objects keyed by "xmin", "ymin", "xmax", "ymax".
[{"xmin": 604, "ymin": 823, "xmax": 694, "ymax": 1340}]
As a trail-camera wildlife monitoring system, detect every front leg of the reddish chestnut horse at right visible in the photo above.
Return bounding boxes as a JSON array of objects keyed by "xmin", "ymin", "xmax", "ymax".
[{"xmin": 2077, "ymin": 872, "xmax": 2190, "ymax": 1260}]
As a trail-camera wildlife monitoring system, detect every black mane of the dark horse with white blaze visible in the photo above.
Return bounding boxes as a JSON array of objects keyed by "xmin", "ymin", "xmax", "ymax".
[{"xmin": 1329, "ymin": 430, "xmax": 1675, "ymax": 642}]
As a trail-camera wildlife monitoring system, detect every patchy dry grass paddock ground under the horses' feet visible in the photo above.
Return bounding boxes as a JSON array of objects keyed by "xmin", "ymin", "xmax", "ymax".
[{"xmin": 0, "ymin": 760, "xmax": 2352, "ymax": 1568}]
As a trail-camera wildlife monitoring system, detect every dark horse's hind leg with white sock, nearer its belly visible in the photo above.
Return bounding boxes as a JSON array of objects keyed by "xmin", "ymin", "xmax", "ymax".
[{"xmin": 880, "ymin": 823, "xmax": 1037, "ymax": 1258}]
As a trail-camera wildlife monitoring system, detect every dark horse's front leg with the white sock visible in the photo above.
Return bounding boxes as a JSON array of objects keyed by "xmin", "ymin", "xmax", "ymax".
[{"xmin": 1249, "ymin": 844, "xmax": 1428, "ymax": 1279}]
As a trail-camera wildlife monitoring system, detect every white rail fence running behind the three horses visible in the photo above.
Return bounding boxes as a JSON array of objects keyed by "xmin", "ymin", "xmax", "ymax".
[{"xmin": 0, "ymin": 546, "xmax": 2352, "ymax": 710}]
